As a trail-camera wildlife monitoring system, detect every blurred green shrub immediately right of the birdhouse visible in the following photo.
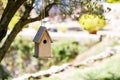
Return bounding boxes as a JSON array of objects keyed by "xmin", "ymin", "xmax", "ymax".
[{"xmin": 52, "ymin": 41, "xmax": 79, "ymax": 63}]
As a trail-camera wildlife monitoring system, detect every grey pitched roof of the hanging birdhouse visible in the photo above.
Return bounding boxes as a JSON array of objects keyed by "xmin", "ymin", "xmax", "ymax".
[{"xmin": 33, "ymin": 26, "xmax": 52, "ymax": 43}]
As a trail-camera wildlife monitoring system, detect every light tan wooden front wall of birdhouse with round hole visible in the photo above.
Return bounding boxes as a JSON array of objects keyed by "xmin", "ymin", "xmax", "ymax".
[{"xmin": 39, "ymin": 32, "xmax": 52, "ymax": 58}]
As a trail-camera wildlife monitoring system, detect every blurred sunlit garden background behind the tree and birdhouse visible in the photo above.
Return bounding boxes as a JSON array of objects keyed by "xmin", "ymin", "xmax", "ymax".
[{"xmin": 0, "ymin": 0, "xmax": 120, "ymax": 80}]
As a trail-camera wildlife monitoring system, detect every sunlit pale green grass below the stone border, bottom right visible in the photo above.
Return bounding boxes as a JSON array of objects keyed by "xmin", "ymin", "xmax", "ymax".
[{"xmin": 45, "ymin": 53, "xmax": 120, "ymax": 80}]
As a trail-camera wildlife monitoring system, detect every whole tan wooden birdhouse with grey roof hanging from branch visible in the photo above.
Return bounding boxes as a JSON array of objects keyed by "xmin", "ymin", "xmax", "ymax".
[{"xmin": 33, "ymin": 26, "xmax": 52, "ymax": 58}]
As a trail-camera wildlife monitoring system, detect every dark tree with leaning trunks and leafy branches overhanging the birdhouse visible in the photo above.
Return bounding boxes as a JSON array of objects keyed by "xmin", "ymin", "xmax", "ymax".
[{"xmin": 0, "ymin": 0, "xmax": 106, "ymax": 61}]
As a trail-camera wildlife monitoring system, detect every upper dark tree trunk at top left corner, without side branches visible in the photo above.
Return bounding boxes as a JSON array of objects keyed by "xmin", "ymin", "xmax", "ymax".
[{"xmin": 0, "ymin": 0, "xmax": 26, "ymax": 42}]
